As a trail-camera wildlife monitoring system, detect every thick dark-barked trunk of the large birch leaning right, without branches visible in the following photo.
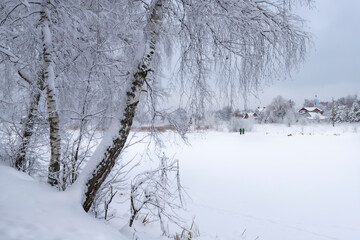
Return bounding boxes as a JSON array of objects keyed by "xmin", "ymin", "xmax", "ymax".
[{"xmin": 83, "ymin": 0, "xmax": 163, "ymax": 212}]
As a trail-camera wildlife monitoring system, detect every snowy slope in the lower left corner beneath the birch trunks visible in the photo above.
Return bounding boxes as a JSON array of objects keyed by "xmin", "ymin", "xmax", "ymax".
[{"xmin": 0, "ymin": 165, "xmax": 127, "ymax": 240}]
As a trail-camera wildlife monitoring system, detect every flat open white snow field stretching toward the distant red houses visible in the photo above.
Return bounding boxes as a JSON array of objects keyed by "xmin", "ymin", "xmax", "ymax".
[{"xmin": 119, "ymin": 124, "xmax": 360, "ymax": 240}]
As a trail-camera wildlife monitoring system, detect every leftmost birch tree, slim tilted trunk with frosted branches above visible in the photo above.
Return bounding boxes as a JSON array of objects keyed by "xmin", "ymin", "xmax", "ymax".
[{"xmin": 0, "ymin": 1, "xmax": 44, "ymax": 171}]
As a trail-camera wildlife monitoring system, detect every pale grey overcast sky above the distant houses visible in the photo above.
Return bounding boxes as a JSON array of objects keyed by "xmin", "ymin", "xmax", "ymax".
[{"xmin": 249, "ymin": 0, "xmax": 360, "ymax": 107}]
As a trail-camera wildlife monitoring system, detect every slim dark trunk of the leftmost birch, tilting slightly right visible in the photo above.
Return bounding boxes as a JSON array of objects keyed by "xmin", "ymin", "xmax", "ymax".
[{"xmin": 15, "ymin": 77, "xmax": 41, "ymax": 171}]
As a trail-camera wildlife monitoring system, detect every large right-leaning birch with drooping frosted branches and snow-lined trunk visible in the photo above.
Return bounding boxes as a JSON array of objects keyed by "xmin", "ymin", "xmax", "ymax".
[{"xmin": 80, "ymin": 0, "xmax": 309, "ymax": 211}]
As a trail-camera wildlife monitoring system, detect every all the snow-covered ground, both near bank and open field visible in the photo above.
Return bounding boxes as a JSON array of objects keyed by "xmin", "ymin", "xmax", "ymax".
[{"xmin": 0, "ymin": 125, "xmax": 360, "ymax": 240}]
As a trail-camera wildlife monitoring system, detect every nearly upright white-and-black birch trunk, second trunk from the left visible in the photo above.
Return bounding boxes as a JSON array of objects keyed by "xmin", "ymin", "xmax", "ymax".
[{"xmin": 40, "ymin": 0, "xmax": 61, "ymax": 186}]
